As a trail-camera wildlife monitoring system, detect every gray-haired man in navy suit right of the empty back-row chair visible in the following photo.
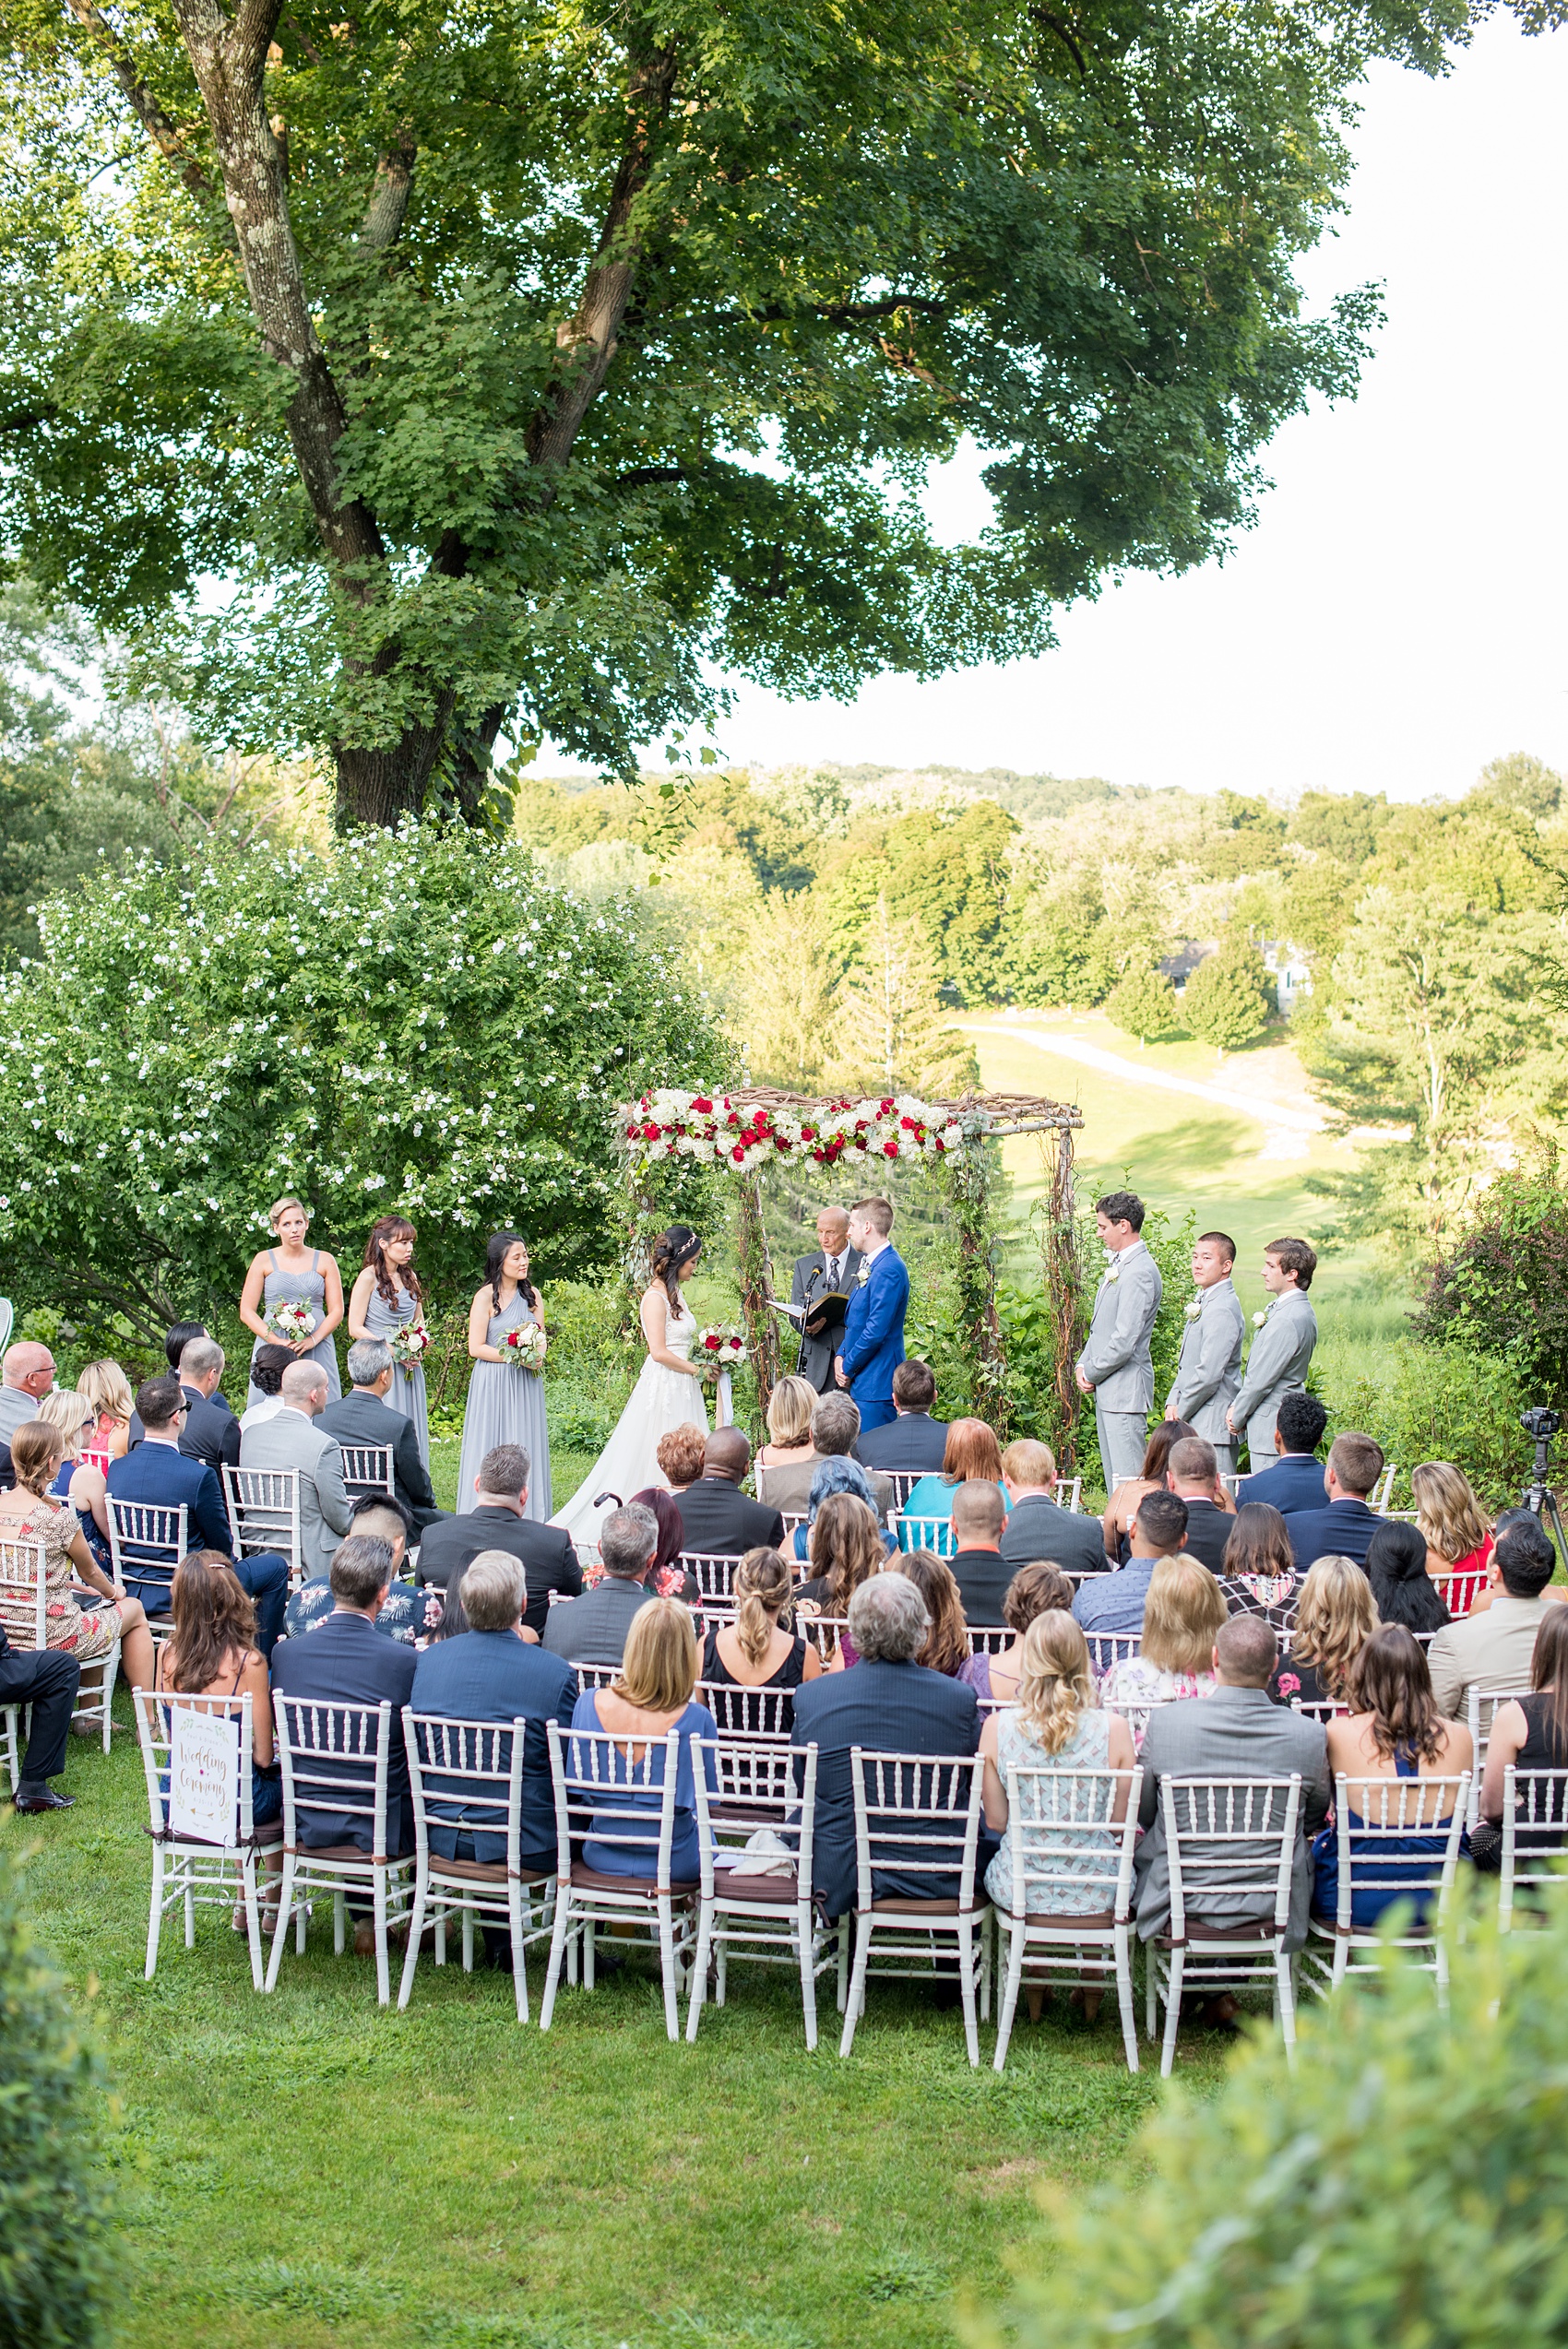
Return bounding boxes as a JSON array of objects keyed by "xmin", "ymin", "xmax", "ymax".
[{"xmin": 790, "ymin": 1578, "xmax": 990, "ymax": 1916}]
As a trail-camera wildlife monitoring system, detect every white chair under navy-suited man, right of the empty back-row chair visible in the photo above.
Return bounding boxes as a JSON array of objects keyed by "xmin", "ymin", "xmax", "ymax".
[{"xmin": 839, "ymin": 1745, "xmax": 992, "ymax": 2065}]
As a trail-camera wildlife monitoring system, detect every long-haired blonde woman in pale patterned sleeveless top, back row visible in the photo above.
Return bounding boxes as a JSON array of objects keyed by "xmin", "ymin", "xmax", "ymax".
[{"xmin": 980, "ymin": 1611, "xmax": 1135, "ymax": 2023}]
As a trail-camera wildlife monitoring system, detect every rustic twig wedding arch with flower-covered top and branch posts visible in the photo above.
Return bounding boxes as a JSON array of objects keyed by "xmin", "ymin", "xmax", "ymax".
[{"xmin": 616, "ymin": 1086, "xmax": 1084, "ymax": 1430}]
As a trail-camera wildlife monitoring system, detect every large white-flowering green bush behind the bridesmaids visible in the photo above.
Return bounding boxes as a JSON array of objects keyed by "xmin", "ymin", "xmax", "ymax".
[{"xmin": 0, "ymin": 827, "xmax": 717, "ymax": 1323}]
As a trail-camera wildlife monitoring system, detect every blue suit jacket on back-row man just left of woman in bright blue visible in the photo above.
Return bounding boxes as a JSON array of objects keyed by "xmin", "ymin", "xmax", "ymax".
[{"xmin": 409, "ymin": 1631, "xmax": 578, "ymax": 1868}]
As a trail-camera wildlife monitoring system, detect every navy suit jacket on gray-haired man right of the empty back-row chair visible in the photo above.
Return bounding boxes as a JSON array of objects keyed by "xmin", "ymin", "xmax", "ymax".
[{"xmin": 790, "ymin": 1663, "xmax": 997, "ymax": 1916}]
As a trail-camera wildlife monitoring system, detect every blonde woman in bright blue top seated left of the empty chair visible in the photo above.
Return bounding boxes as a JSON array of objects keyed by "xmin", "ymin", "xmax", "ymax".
[{"xmin": 571, "ymin": 1593, "xmax": 719, "ymax": 1884}]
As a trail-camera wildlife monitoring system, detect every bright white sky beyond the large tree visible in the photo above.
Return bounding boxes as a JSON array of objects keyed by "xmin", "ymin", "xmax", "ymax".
[{"xmin": 592, "ymin": 18, "xmax": 1568, "ymax": 799}]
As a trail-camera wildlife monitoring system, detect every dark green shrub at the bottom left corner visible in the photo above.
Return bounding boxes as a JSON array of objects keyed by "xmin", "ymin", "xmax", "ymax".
[{"xmin": 0, "ymin": 1846, "xmax": 108, "ymax": 2349}]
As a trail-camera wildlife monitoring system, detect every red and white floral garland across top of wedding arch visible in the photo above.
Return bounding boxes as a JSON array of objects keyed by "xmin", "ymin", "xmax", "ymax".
[{"xmin": 621, "ymin": 1086, "xmax": 964, "ymax": 1175}]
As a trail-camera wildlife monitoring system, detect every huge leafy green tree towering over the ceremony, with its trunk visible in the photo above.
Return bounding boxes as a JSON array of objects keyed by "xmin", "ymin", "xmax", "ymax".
[{"xmin": 0, "ymin": 0, "xmax": 1467, "ymax": 822}]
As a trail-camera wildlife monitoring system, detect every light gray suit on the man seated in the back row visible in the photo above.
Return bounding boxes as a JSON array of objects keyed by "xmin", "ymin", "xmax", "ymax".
[{"xmin": 1133, "ymin": 1687, "xmax": 1333, "ymax": 1950}]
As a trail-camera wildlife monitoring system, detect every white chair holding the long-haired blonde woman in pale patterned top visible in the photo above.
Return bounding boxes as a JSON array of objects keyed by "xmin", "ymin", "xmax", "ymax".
[{"xmin": 994, "ymin": 1764, "xmax": 1143, "ymax": 2071}]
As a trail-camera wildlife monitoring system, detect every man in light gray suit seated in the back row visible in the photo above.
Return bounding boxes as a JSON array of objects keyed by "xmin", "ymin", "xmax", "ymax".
[{"xmin": 1135, "ymin": 1616, "xmax": 1333, "ymax": 1963}]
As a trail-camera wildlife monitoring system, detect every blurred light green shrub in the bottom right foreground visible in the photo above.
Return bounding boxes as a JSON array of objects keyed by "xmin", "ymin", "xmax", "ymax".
[{"xmin": 987, "ymin": 1895, "xmax": 1568, "ymax": 2349}]
